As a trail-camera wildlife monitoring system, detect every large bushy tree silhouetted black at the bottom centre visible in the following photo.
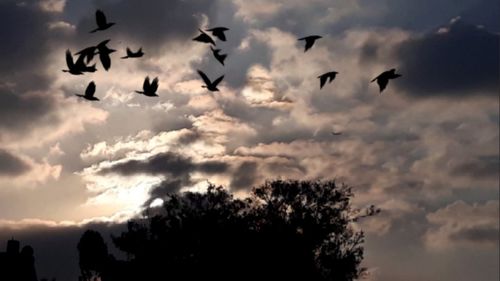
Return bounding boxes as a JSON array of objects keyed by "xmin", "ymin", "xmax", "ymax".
[{"xmin": 79, "ymin": 180, "xmax": 377, "ymax": 281}]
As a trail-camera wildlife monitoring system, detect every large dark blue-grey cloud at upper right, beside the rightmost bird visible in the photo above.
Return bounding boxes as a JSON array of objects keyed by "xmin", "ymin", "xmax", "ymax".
[{"xmin": 395, "ymin": 20, "xmax": 500, "ymax": 96}]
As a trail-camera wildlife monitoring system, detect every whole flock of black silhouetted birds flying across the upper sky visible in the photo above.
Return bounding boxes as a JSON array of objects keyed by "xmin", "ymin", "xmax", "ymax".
[{"xmin": 63, "ymin": 10, "xmax": 401, "ymax": 106}]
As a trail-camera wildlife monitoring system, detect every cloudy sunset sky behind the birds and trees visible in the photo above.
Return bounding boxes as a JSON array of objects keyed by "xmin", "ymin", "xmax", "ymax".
[{"xmin": 0, "ymin": 0, "xmax": 500, "ymax": 281}]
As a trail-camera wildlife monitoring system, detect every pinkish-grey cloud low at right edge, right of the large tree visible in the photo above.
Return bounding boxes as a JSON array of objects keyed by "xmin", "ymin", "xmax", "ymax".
[{"xmin": 424, "ymin": 201, "xmax": 499, "ymax": 247}]
